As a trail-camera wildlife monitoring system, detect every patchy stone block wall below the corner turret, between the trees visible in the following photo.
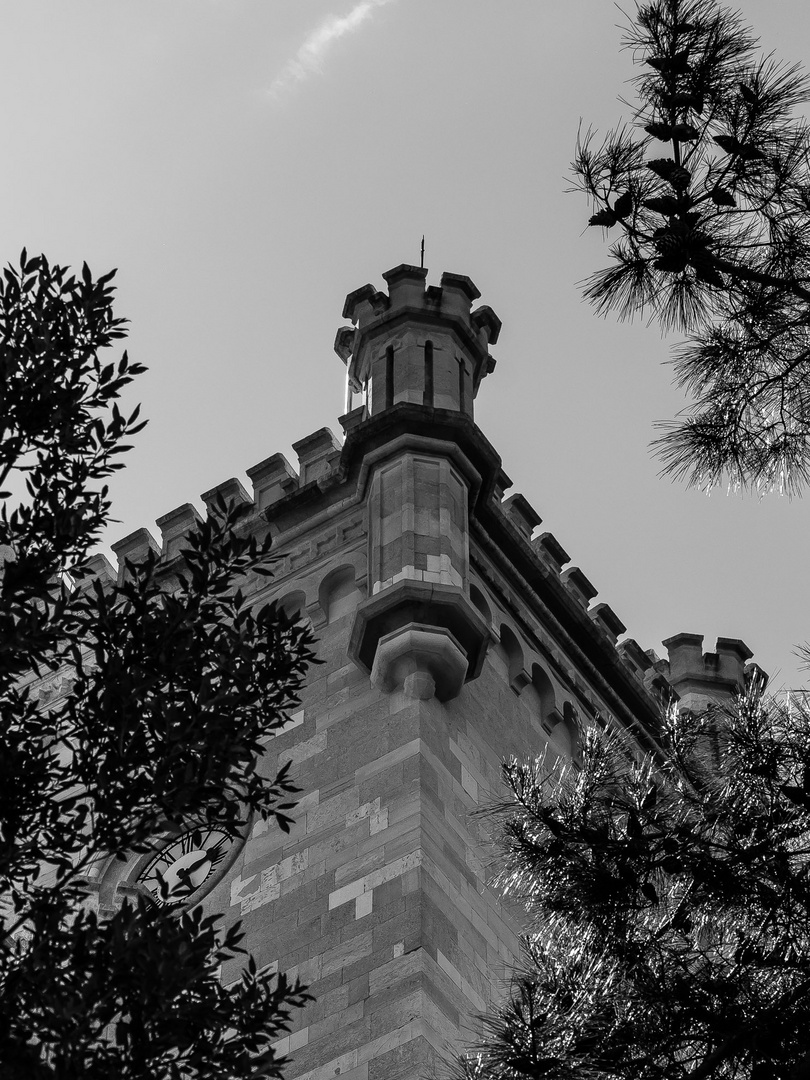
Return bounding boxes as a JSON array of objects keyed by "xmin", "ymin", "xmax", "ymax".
[{"xmin": 205, "ymin": 557, "xmax": 557, "ymax": 1080}]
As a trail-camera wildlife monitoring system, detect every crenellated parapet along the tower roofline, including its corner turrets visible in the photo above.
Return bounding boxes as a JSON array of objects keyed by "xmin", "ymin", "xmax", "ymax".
[{"xmin": 94, "ymin": 264, "xmax": 764, "ymax": 724}]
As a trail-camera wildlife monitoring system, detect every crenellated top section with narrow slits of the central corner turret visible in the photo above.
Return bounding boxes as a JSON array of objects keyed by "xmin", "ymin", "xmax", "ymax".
[{"xmin": 335, "ymin": 262, "xmax": 501, "ymax": 416}]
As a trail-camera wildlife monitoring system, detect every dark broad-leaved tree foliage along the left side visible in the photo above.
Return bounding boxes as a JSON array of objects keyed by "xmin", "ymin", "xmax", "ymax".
[{"xmin": 0, "ymin": 252, "xmax": 312, "ymax": 1080}]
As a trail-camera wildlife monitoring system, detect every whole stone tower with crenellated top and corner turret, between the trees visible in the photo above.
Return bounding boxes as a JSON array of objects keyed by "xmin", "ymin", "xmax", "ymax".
[{"xmin": 79, "ymin": 266, "xmax": 760, "ymax": 1080}]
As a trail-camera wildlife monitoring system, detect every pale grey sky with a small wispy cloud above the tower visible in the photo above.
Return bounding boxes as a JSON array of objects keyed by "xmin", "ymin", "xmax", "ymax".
[{"xmin": 6, "ymin": 0, "xmax": 810, "ymax": 686}]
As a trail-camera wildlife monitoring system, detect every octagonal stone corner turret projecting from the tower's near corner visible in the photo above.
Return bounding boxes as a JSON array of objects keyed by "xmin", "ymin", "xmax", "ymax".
[{"xmin": 335, "ymin": 264, "xmax": 501, "ymax": 701}]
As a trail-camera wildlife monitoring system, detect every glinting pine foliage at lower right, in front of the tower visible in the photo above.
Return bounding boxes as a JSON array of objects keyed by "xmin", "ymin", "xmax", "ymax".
[{"xmin": 458, "ymin": 677, "xmax": 810, "ymax": 1080}]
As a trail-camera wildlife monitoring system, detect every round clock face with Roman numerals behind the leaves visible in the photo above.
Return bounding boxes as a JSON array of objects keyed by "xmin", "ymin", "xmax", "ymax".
[{"xmin": 138, "ymin": 825, "xmax": 235, "ymax": 906}]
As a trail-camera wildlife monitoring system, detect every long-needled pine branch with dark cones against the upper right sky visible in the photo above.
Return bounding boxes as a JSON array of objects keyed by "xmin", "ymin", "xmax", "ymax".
[{"xmin": 573, "ymin": 0, "xmax": 810, "ymax": 492}]
